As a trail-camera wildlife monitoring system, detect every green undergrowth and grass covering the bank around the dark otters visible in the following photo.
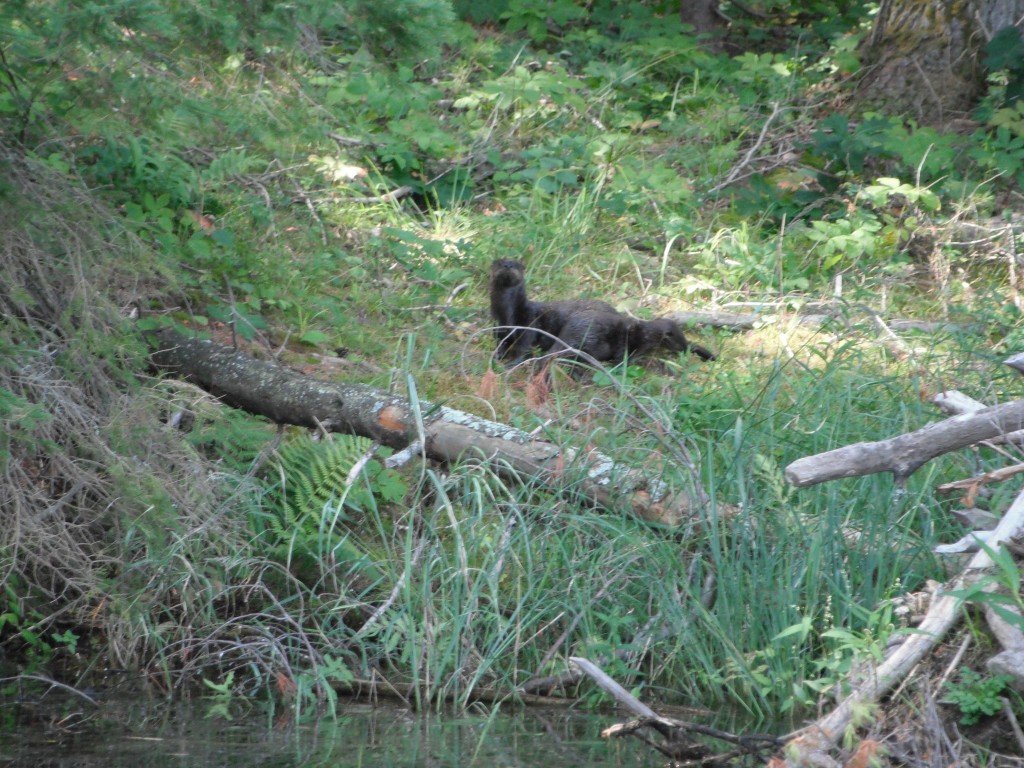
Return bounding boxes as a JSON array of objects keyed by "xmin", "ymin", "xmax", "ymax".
[{"xmin": 0, "ymin": 0, "xmax": 1024, "ymax": 745}]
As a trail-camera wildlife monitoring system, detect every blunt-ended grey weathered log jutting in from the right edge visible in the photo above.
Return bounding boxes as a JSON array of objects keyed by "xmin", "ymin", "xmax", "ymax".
[{"xmin": 785, "ymin": 400, "xmax": 1024, "ymax": 486}]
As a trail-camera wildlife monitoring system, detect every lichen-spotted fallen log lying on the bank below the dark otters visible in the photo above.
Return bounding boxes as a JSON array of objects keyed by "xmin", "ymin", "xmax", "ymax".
[{"xmin": 150, "ymin": 330, "xmax": 707, "ymax": 525}]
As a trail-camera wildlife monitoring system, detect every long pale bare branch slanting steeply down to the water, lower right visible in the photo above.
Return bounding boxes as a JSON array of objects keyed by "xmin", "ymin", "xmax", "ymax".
[{"xmin": 785, "ymin": 492, "xmax": 1024, "ymax": 767}]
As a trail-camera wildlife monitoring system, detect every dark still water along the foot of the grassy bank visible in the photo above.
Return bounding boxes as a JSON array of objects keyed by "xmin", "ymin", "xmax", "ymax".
[{"xmin": 0, "ymin": 691, "xmax": 666, "ymax": 768}]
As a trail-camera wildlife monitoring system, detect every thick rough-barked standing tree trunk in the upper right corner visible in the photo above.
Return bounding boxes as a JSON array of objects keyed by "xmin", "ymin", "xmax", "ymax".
[{"xmin": 857, "ymin": 0, "xmax": 1024, "ymax": 126}]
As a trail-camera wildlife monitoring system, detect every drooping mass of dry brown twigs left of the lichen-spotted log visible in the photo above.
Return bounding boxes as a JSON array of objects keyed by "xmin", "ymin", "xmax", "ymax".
[{"xmin": 0, "ymin": 145, "xmax": 247, "ymax": 665}]
